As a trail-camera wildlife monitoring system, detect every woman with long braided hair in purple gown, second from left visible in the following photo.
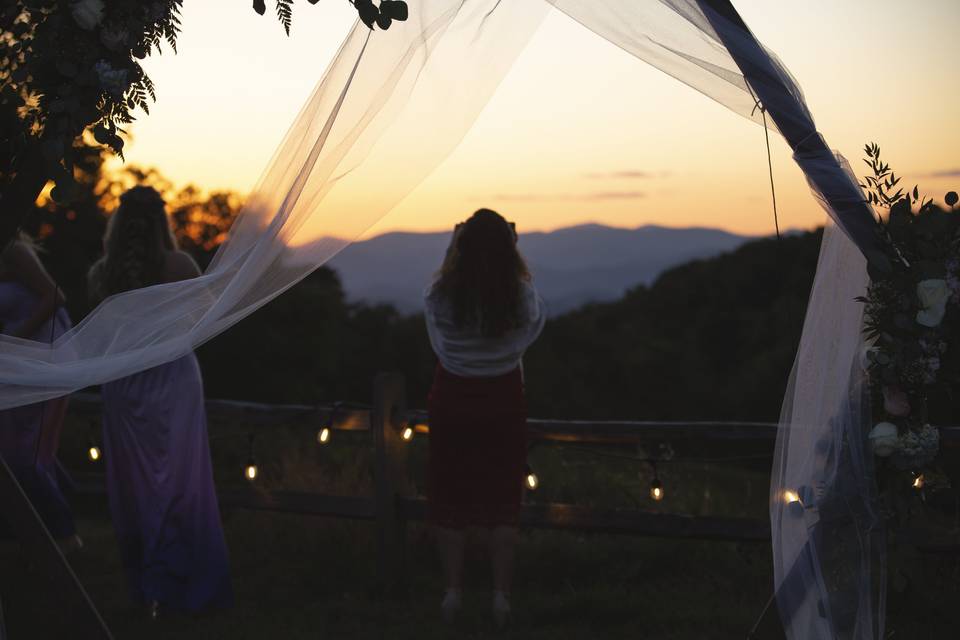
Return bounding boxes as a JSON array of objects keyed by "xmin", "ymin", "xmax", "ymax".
[{"xmin": 89, "ymin": 187, "xmax": 233, "ymax": 616}]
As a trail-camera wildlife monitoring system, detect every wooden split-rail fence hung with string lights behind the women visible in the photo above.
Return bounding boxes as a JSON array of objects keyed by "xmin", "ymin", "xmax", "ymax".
[{"xmin": 65, "ymin": 374, "xmax": 960, "ymax": 589}]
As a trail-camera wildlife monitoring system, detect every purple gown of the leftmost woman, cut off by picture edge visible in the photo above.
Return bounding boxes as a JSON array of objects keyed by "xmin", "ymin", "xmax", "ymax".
[{"xmin": 0, "ymin": 280, "xmax": 76, "ymax": 538}]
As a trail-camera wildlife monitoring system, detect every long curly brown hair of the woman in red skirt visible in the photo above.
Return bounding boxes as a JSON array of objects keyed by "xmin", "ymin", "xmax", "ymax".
[{"xmin": 433, "ymin": 209, "xmax": 530, "ymax": 337}]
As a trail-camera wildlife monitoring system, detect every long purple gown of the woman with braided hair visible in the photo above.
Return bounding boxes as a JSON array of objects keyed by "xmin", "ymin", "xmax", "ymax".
[{"xmin": 101, "ymin": 354, "xmax": 233, "ymax": 612}]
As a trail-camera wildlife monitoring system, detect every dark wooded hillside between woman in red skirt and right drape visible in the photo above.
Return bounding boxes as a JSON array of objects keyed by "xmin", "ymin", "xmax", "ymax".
[{"xmin": 524, "ymin": 232, "xmax": 820, "ymax": 420}]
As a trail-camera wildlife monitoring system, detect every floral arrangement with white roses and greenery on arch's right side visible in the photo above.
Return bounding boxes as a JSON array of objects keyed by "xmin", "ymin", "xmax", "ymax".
[{"xmin": 859, "ymin": 144, "xmax": 960, "ymax": 489}]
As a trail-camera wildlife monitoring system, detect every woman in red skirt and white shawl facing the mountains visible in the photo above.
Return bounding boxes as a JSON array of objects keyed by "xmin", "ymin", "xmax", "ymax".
[{"xmin": 425, "ymin": 209, "xmax": 545, "ymax": 626}]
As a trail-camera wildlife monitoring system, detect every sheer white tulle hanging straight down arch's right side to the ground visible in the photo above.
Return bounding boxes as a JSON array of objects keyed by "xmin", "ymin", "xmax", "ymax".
[{"xmin": 770, "ymin": 160, "xmax": 886, "ymax": 640}]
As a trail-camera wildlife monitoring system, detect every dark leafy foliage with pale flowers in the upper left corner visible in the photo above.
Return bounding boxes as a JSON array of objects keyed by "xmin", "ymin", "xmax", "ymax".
[{"xmin": 0, "ymin": 0, "xmax": 182, "ymax": 200}]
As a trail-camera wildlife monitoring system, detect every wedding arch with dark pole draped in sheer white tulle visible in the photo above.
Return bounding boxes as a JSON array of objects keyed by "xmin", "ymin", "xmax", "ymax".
[{"xmin": 0, "ymin": 0, "xmax": 889, "ymax": 640}]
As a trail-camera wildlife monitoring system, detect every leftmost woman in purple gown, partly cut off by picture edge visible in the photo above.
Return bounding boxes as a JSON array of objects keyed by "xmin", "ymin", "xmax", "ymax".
[{"xmin": 0, "ymin": 236, "xmax": 82, "ymax": 551}]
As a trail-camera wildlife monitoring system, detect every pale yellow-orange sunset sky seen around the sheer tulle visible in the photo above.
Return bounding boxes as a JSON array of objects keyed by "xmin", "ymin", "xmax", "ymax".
[{"xmin": 114, "ymin": 0, "xmax": 960, "ymax": 234}]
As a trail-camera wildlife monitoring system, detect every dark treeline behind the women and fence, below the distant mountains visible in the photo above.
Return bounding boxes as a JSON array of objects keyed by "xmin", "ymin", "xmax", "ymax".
[{"xmin": 27, "ymin": 148, "xmax": 820, "ymax": 420}]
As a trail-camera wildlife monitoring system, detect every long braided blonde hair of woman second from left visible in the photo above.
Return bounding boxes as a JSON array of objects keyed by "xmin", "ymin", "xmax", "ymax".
[{"xmin": 89, "ymin": 187, "xmax": 177, "ymax": 302}]
